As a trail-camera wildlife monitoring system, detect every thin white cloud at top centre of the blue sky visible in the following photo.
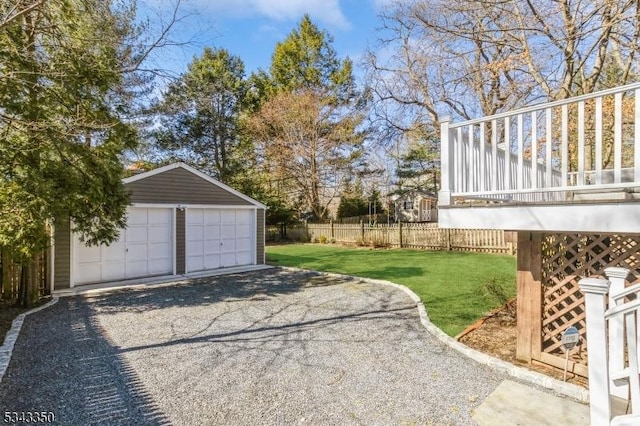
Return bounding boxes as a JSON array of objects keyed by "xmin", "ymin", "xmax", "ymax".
[{"xmin": 192, "ymin": 0, "xmax": 351, "ymax": 30}]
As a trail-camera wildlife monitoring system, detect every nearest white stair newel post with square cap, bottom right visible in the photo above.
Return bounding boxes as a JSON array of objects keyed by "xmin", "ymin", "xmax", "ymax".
[{"xmin": 578, "ymin": 278, "xmax": 611, "ymax": 425}]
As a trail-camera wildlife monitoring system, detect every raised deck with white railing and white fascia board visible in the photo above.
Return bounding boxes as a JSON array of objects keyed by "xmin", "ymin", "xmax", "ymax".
[{"xmin": 438, "ymin": 83, "xmax": 640, "ymax": 233}]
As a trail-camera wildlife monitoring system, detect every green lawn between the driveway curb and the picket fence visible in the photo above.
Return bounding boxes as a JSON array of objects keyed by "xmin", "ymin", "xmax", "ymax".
[{"xmin": 267, "ymin": 244, "xmax": 516, "ymax": 336}]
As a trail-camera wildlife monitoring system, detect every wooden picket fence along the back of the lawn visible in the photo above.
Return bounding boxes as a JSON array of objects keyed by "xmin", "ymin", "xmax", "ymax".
[{"xmin": 266, "ymin": 222, "xmax": 516, "ymax": 255}]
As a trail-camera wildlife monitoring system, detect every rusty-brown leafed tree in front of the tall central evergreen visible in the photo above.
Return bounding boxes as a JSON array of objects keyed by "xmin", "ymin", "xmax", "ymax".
[{"xmin": 247, "ymin": 91, "xmax": 363, "ymax": 219}]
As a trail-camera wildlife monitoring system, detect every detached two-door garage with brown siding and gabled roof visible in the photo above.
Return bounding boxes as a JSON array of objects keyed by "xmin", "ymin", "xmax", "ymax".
[{"xmin": 52, "ymin": 163, "xmax": 265, "ymax": 290}]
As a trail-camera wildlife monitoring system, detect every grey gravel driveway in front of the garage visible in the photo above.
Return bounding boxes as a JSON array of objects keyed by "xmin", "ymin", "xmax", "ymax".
[{"xmin": 0, "ymin": 269, "xmax": 504, "ymax": 425}]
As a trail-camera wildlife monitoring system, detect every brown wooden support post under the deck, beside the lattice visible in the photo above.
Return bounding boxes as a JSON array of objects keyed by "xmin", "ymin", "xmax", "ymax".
[{"xmin": 516, "ymin": 231, "xmax": 542, "ymax": 362}]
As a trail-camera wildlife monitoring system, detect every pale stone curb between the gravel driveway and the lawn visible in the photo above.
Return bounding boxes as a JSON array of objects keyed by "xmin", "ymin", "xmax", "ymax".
[{"xmin": 280, "ymin": 267, "xmax": 589, "ymax": 404}]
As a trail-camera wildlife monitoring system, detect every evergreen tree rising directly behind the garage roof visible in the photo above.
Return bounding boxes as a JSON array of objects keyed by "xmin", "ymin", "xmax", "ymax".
[{"xmin": 155, "ymin": 47, "xmax": 253, "ymax": 188}]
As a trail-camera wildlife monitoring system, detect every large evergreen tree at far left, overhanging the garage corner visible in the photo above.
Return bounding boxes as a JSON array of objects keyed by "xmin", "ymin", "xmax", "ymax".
[{"xmin": 0, "ymin": 0, "xmax": 159, "ymax": 305}]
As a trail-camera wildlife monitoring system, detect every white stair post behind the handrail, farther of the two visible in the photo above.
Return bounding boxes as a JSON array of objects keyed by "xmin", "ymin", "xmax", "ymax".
[{"xmin": 604, "ymin": 267, "xmax": 630, "ymax": 399}]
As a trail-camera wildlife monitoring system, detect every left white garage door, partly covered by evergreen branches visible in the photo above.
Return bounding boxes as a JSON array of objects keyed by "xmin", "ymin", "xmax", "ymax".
[{"xmin": 73, "ymin": 207, "xmax": 173, "ymax": 284}]
